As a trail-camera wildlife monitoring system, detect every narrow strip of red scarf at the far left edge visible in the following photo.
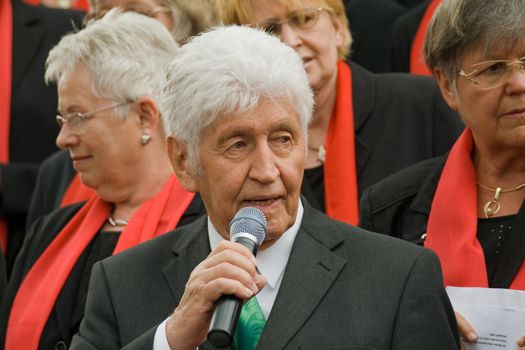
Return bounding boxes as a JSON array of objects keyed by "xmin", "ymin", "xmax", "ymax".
[{"xmin": 0, "ymin": 0, "xmax": 13, "ymax": 253}]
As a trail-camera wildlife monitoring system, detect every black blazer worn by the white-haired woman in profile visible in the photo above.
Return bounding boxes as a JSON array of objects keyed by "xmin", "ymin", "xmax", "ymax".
[{"xmin": 0, "ymin": 194, "xmax": 205, "ymax": 349}]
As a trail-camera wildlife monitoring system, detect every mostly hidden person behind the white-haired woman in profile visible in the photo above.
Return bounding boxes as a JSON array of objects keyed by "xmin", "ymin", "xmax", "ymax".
[{"xmin": 27, "ymin": 0, "xmax": 218, "ymax": 238}]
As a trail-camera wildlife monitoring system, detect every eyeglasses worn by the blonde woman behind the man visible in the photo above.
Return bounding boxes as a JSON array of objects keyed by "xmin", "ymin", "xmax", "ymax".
[{"xmin": 257, "ymin": 7, "xmax": 330, "ymax": 36}]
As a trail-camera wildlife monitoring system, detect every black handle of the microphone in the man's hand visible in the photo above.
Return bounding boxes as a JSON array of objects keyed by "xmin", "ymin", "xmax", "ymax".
[{"xmin": 208, "ymin": 236, "xmax": 258, "ymax": 348}]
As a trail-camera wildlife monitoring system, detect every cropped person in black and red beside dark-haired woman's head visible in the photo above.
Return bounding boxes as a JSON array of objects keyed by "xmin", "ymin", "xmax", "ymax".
[{"xmin": 388, "ymin": 0, "xmax": 441, "ymax": 75}]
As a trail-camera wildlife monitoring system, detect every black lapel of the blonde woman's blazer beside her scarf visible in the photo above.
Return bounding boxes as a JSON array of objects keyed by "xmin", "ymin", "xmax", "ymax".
[{"xmin": 348, "ymin": 62, "xmax": 376, "ymax": 178}]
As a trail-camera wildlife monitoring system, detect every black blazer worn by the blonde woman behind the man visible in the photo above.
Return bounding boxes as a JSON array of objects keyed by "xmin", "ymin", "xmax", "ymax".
[{"xmin": 303, "ymin": 62, "xmax": 464, "ymax": 209}]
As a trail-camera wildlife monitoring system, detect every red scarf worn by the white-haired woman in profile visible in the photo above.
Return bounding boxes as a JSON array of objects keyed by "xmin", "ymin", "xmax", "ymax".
[{"xmin": 5, "ymin": 175, "xmax": 195, "ymax": 350}]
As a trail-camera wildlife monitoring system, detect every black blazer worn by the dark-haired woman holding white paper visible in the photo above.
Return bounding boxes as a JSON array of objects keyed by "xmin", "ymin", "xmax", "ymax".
[{"xmin": 359, "ymin": 156, "xmax": 525, "ymax": 288}]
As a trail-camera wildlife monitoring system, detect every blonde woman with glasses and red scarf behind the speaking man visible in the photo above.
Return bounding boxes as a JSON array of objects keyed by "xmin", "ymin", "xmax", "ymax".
[{"xmin": 222, "ymin": 0, "xmax": 463, "ymax": 224}]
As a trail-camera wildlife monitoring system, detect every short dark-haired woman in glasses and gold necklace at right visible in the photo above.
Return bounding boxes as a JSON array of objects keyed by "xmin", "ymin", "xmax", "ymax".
[{"xmin": 360, "ymin": 0, "xmax": 525, "ymax": 348}]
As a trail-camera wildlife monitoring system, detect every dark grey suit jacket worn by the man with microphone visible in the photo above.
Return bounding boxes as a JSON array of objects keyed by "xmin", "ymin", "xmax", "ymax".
[{"xmin": 71, "ymin": 201, "xmax": 459, "ymax": 350}]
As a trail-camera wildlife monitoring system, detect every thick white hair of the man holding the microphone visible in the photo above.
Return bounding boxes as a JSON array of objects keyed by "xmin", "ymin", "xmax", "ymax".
[{"xmin": 160, "ymin": 26, "xmax": 314, "ymax": 170}]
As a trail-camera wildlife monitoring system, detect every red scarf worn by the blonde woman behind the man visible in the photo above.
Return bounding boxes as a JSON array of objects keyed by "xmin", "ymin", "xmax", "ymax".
[{"xmin": 324, "ymin": 61, "xmax": 359, "ymax": 225}]
